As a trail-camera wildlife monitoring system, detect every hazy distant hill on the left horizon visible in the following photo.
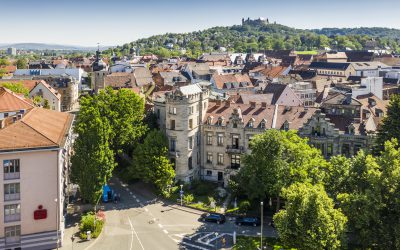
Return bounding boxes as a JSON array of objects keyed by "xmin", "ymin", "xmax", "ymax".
[{"xmin": 0, "ymin": 43, "xmax": 109, "ymax": 51}]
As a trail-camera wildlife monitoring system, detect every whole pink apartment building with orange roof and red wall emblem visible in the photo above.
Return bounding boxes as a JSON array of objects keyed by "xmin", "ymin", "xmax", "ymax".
[{"xmin": 0, "ymin": 105, "xmax": 73, "ymax": 250}]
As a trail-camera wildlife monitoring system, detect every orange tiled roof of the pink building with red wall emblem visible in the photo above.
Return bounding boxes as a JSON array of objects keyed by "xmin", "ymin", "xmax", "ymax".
[{"xmin": 0, "ymin": 108, "xmax": 73, "ymax": 151}]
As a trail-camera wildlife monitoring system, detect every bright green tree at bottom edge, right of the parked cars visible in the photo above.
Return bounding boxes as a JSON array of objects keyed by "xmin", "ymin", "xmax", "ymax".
[{"xmin": 274, "ymin": 183, "xmax": 347, "ymax": 250}]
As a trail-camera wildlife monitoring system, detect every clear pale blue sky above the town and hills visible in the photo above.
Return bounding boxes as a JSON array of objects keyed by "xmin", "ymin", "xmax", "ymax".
[{"xmin": 0, "ymin": 0, "xmax": 400, "ymax": 47}]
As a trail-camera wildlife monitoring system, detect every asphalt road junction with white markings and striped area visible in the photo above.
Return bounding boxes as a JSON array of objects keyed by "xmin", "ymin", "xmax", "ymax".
[{"xmin": 87, "ymin": 179, "xmax": 274, "ymax": 250}]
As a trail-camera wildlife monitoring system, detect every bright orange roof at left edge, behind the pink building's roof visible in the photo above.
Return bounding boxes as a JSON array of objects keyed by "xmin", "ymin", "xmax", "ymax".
[{"xmin": 0, "ymin": 87, "xmax": 34, "ymax": 112}]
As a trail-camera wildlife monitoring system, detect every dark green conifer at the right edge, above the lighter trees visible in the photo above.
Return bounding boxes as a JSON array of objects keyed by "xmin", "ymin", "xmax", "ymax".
[{"xmin": 376, "ymin": 95, "xmax": 400, "ymax": 153}]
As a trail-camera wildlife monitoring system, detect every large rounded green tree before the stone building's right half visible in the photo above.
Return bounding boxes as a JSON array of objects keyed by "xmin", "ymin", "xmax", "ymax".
[{"xmin": 238, "ymin": 129, "xmax": 326, "ymax": 209}]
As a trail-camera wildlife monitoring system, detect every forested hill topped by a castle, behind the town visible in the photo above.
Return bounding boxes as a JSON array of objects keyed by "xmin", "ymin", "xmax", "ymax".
[{"xmin": 104, "ymin": 19, "xmax": 400, "ymax": 57}]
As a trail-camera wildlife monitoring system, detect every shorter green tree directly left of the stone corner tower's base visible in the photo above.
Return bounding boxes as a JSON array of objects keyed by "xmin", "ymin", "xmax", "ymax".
[{"xmin": 129, "ymin": 130, "xmax": 175, "ymax": 192}]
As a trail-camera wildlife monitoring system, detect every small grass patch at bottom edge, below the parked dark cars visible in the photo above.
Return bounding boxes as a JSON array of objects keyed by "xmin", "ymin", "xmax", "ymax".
[{"xmin": 233, "ymin": 236, "xmax": 295, "ymax": 250}]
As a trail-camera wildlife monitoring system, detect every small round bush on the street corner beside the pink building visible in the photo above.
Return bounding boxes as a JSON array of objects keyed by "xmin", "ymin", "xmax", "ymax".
[{"xmin": 79, "ymin": 212, "xmax": 104, "ymax": 239}]
